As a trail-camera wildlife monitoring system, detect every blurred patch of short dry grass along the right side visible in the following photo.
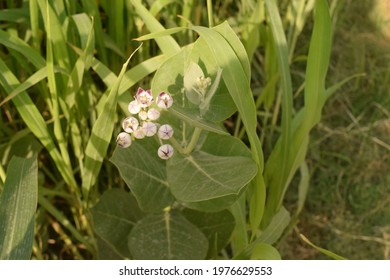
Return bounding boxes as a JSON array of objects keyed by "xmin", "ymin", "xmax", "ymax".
[{"xmin": 283, "ymin": 1, "xmax": 390, "ymax": 259}]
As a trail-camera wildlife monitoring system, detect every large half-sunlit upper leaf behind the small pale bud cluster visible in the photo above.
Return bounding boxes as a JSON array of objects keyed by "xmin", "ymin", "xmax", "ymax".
[{"xmin": 152, "ymin": 42, "xmax": 237, "ymax": 123}]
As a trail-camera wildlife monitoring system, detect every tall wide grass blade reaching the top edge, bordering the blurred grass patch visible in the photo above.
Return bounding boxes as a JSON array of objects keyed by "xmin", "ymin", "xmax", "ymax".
[{"xmin": 263, "ymin": 0, "xmax": 331, "ymax": 226}]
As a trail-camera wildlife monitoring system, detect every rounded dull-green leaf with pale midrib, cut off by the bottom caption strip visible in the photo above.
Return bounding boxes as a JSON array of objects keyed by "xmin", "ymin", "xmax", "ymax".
[{"xmin": 128, "ymin": 211, "xmax": 208, "ymax": 260}]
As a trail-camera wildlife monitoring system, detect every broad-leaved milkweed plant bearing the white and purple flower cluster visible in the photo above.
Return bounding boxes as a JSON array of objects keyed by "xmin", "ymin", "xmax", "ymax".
[{"xmin": 93, "ymin": 54, "xmax": 257, "ymax": 259}]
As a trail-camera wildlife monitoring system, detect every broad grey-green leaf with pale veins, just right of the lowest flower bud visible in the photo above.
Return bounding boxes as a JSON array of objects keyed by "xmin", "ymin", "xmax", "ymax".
[{"xmin": 168, "ymin": 152, "xmax": 257, "ymax": 202}]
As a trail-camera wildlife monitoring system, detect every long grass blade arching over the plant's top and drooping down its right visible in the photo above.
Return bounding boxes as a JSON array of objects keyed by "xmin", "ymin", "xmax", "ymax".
[{"xmin": 191, "ymin": 22, "xmax": 265, "ymax": 231}]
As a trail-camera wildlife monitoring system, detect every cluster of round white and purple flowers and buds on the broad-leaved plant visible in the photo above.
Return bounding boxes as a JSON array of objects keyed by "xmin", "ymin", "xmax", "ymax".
[{"xmin": 116, "ymin": 88, "xmax": 173, "ymax": 159}]
